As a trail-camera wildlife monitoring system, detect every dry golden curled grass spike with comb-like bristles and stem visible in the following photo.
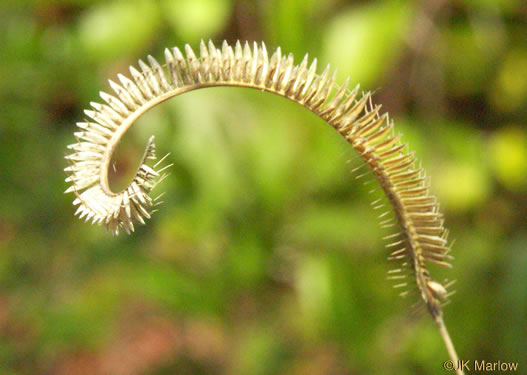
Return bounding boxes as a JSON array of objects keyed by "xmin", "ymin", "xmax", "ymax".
[{"xmin": 65, "ymin": 41, "xmax": 462, "ymax": 374}]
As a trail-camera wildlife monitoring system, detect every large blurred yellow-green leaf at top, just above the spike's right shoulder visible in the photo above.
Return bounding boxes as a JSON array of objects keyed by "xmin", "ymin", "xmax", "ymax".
[{"xmin": 323, "ymin": 1, "xmax": 412, "ymax": 87}]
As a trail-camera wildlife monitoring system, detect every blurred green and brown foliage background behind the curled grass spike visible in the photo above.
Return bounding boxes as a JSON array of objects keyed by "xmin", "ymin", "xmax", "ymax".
[{"xmin": 0, "ymin": 0, "xmax": 527, "ymax": 375}]
